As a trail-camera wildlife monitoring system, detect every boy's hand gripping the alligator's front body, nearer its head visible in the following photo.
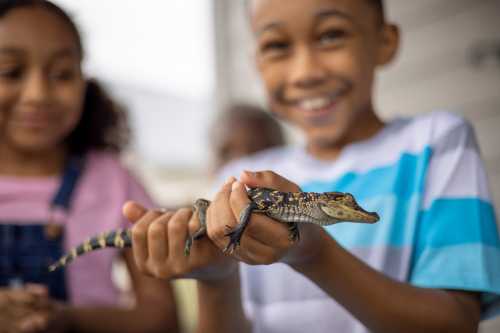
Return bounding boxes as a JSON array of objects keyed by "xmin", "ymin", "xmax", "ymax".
[{"xmin": 207, "ymin": 171, "xmax": 324, "ymax": 265}]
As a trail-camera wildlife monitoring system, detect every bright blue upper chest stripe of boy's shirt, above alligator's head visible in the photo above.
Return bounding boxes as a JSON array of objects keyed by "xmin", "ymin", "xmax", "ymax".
[{"xmin": 301, "ymin": 147, "xmax": 432, "ymax": 198}]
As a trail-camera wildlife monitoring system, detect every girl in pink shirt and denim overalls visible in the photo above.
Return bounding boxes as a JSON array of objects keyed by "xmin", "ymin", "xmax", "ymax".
[{"xmin": 0, "ymin": 0, "xmax": 177, "ymax": 333}]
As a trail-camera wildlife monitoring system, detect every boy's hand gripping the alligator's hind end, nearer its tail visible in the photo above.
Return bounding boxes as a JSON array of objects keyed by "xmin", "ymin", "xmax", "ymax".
[{"xmin": 123, "ymin": 198, "xmax": 237, "ymax": 280}]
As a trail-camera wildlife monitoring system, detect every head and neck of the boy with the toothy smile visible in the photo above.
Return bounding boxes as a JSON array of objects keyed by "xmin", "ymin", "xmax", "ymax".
[{"xmin": 251, "ymin": 0, "xmax": 397, "ymax": 157}]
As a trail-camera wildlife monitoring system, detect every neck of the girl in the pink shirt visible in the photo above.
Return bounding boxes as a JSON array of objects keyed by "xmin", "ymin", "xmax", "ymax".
[{"xmin": 0, "ymin": 143, "xmax": 66, "ymax": 177}]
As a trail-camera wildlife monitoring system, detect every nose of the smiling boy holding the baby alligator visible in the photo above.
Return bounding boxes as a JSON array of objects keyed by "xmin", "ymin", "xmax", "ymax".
[{"xmin": 288, "ymin": 47, "xmax": 328, "ymax": 89}]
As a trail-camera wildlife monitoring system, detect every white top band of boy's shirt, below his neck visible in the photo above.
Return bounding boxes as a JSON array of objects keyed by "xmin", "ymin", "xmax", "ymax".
[{"xmin": 220, "ymin": 112, "xmax": 465, "ymax": 183}]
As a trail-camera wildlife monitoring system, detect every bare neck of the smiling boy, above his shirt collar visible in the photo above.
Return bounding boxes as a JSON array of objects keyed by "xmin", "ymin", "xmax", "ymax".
[{"xmin": 307, "ymin": 112, "xmax": 384, "ymax": 161}]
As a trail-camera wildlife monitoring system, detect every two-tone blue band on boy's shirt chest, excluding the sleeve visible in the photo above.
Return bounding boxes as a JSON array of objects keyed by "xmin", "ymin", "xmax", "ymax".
[{"xmin": 301, "ymin": 147, "xmax": 432, "ymax": 248}]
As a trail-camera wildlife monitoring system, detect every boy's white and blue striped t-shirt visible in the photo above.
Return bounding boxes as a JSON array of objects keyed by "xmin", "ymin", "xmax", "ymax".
[{"xmin": 221, "ymin": 112, "xmax": 500, "ymax": 333}]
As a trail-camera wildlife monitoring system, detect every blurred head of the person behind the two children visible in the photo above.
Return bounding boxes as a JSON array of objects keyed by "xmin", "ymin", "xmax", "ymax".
[{"xmin": 210, "ymin": 104, "xmax": 285, "ymax": 171}]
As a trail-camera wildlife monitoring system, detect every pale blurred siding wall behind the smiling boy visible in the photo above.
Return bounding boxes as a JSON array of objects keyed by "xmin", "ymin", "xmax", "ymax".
[{"xmin": 214, "ymin": 0, "xmax": 500, "ymax": 333}]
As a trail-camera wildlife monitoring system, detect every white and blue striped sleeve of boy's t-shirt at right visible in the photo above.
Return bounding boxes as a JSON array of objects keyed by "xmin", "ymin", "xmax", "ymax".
[{"xmin": 410, "ymin": 120, "xmax": 500, "ymax": 318}]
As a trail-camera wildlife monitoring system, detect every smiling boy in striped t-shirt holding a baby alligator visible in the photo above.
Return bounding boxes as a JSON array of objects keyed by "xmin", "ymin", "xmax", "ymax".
[{"xmin": 124, "ymin": 0, "xmax": 500, "ymax": 333}]
